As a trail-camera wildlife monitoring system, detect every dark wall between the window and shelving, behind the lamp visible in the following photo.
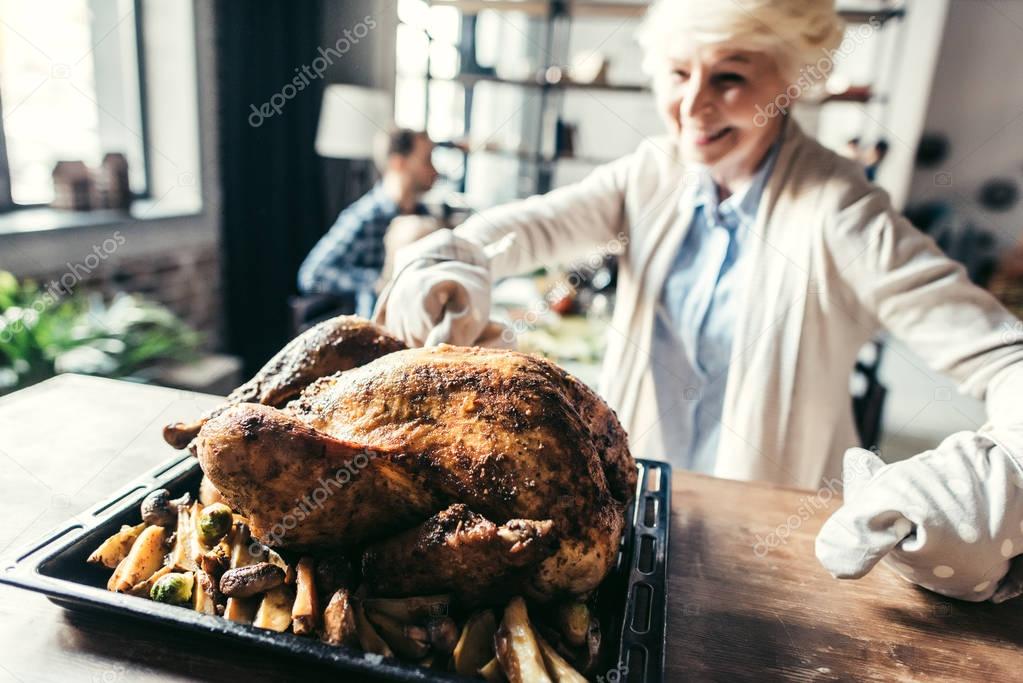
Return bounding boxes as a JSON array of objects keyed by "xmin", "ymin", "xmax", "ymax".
[{"xmin": 215, "ymin": 0, "xmax": 395, "ymax": 374}]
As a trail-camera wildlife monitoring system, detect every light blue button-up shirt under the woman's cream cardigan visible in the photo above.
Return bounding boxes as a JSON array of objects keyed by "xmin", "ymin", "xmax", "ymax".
[{"xmin": 652, "ymin": 143, "xmax": 780, "ymax": 473}]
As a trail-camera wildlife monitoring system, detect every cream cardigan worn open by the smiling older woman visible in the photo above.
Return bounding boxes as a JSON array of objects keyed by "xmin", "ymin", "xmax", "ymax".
[{"xmin": 455, "ymin": 120, "xmax": 1023, "ymax": 488}]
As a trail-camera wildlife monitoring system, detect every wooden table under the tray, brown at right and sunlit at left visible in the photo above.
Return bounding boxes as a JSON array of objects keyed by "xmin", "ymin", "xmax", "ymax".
[{"xmin": 0, "ymin": 376, "xmax": 1023, "ymax": 683}]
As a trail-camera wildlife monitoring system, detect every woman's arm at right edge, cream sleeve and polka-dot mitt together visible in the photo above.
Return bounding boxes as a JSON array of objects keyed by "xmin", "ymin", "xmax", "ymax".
[{"xmin": 816, "ymin": 180, "xmax": 1023, "ymax": 602}]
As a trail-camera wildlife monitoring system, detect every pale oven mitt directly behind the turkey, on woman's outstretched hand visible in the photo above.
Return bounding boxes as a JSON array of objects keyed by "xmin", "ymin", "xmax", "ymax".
[{"xmin": 373, "ymin": 230, "xmax": 515, "ymax": 348}]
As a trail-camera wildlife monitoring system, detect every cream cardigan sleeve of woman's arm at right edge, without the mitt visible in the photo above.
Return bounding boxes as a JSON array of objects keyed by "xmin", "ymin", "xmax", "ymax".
[{"xmin": 827, "ymin": 188, "xmax": 1023, "ymax": 411}]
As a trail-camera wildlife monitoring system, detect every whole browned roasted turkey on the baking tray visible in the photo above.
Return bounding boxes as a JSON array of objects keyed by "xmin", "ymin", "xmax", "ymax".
[{"xmin": 180, "ymin": 319, "xmax": 636, "ymax": 603}]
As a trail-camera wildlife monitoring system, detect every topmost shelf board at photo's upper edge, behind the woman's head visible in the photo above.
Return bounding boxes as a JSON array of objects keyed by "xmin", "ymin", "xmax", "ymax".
[{"xmin": 431, "ymin": 0, "xmax": 905, "ymax": 25}]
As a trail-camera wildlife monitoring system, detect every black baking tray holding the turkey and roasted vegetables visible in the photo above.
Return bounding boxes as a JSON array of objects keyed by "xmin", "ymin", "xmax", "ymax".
[{"xmin": 0, "ymin": 454, "xmax": 671, "ymax": 683}]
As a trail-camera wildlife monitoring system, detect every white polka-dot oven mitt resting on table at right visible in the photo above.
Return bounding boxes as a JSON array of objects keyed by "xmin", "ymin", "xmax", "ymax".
[{"xmin": 816, "ymin": 431, "xmax": 1023, "ymax": 602}]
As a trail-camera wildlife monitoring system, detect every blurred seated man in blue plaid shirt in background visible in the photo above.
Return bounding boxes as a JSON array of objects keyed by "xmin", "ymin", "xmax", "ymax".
[{"xmin": 299, "ymin": 129, "xmax": 437, "ymax": 317}]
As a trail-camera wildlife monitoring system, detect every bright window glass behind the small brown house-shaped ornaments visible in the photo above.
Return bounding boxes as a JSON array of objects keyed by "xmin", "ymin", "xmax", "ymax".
[{"xmin": 0, "ymin": 0, "xmax": 150, "ymax": 210}]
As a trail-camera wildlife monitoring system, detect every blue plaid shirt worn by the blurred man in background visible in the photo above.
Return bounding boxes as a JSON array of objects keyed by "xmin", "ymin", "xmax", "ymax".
[{"xmin": 299, "ymin": 183, "xmax": 427, "ymax": 298}]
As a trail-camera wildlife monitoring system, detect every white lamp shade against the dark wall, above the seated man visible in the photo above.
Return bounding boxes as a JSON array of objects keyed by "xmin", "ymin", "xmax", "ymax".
[{"xmin": 316, "ymin": 85, "xmax": 391, "ymax": 158}]
